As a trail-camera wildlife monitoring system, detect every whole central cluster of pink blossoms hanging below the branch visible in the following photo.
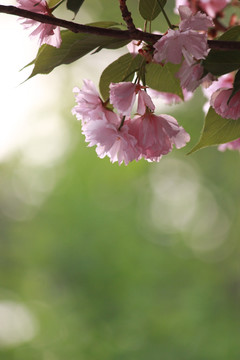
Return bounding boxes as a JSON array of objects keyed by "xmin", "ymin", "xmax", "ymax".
[{"xmin": 72, "ymin": 80, "xmax": 190, "ymax": 165}]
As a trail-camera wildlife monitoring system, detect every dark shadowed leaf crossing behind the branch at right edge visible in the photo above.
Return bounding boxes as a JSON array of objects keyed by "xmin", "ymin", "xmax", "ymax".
[{"xmin": 202, "ymin": 26, "xmax": 240, "ymax": 76}]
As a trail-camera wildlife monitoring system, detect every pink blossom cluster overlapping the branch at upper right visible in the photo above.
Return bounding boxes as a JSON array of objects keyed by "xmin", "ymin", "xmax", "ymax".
[{"xmin": 153, "ymin": 6, "xmax": 214, "ymax": 92}]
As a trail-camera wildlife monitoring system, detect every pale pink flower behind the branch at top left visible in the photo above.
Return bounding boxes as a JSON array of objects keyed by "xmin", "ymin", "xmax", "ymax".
[{"xmin": 17, "ymin": 0, "xmax": 62, "ymax": 48}]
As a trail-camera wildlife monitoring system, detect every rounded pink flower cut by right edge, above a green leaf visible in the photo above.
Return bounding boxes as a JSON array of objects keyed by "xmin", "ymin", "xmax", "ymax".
[{"xmin": 210, "ymin": 88, "xmax": 240, "ymax": 120}]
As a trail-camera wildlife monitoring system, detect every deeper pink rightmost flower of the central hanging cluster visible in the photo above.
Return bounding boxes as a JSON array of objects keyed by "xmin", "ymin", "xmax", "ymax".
[{"xmin": 129, "ymin": 111, "xmax": 190, "ymax": 161}]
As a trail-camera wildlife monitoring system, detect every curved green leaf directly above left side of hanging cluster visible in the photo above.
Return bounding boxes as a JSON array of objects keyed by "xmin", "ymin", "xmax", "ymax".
[{"xmin": 99, "ymin": 54, "xmax": 145, "ymax": 101}]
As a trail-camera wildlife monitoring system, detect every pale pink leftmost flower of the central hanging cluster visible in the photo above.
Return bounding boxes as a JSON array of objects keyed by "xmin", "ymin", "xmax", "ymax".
[{"xmin": 72, "ymin": 80, "xmax": 105, "ymax": 121}]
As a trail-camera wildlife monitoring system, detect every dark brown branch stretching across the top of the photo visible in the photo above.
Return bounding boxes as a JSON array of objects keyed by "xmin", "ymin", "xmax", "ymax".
[{"xmin": 0, "ymin": 5, "xmax": 240, "ymax": 50}]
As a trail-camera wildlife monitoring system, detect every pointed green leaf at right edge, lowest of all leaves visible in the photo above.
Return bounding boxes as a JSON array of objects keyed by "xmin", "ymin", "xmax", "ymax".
[{"xmin": 189, "ymin": 108, "xmax": 240, "ymax": 154}]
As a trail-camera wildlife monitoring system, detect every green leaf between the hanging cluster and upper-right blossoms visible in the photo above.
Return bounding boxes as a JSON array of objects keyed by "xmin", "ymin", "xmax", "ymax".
[{"xmin": 145, "ymin": 63, "xmax": 183, "ymax": 99}]
